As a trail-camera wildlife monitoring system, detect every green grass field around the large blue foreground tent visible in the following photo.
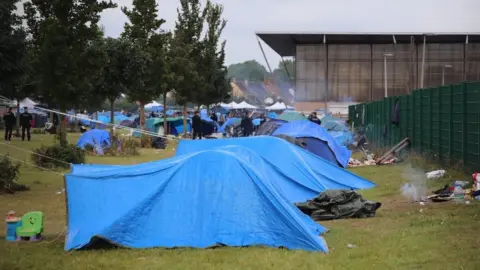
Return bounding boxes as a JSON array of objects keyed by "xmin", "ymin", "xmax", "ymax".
[{"xmin": 0, "ymin": 135, "xmax": 480, "ymax": 270}]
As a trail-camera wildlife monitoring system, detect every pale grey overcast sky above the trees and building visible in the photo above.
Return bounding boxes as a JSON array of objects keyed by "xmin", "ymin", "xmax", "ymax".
[{"xmin": 96, "ymin": 0, "xmax": 480, "ymax": 68}]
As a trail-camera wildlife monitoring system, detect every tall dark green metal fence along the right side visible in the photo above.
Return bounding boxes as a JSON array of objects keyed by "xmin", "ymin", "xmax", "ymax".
[{"xmin": 348, "ymin": 82, "xmax": 480, "ymax": 169}]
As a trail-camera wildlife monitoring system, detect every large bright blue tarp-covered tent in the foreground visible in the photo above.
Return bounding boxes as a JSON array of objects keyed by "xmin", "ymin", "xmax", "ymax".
[{"xmin": 65, "ymin": 150, "xmax": 328, "ymax": 252}]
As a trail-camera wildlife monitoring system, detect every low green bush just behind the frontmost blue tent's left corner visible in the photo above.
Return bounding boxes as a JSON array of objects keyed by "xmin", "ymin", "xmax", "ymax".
[{"xmin": 32, "ymin": 144, "xmax": 85, "ymax": 168}]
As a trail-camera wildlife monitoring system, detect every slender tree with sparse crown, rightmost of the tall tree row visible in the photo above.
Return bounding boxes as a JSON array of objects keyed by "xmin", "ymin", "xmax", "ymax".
[{"xmin": 197, "ymin": 1, "xmax": 232, "ymax": 107}]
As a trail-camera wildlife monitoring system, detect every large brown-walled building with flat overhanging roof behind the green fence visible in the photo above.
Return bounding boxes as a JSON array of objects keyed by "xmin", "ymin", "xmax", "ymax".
[{"xmin": 257, "ymin": 32, "xmax": 480, "ymax": 110}]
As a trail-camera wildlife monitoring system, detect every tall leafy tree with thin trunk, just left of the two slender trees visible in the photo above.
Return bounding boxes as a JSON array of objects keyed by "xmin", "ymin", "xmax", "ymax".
[{"xmin": 122, "ymin": 0, "xmax": 169, "ymax": 133}]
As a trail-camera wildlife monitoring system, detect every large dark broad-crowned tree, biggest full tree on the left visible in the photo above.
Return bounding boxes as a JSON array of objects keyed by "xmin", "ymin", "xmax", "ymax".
[{"xmin": 24, "ymin": 0, "xmax": 116, "ymax": 146}]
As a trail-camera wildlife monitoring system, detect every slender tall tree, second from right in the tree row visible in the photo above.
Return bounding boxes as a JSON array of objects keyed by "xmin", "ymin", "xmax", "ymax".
[{"xmin": 170, "ymin": 0, "xmax": 206, "ymax": 136}]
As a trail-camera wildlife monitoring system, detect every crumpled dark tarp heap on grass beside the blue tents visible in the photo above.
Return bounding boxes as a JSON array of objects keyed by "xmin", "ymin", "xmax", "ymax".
[{"xmin": 295, "ymin": 189, "xmax": 382, "ymax": 221}]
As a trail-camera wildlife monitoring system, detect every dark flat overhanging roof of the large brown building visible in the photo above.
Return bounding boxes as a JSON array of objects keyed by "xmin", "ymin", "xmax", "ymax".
[{"xmin": 256, "ymin": 32, "xmax": 480, "ymax": 56}]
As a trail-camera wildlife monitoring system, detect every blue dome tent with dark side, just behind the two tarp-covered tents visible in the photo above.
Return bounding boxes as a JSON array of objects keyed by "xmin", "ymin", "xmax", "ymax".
[{"xmin": 272, "ymin": 120, "xmax": 352, "ymax": 168}]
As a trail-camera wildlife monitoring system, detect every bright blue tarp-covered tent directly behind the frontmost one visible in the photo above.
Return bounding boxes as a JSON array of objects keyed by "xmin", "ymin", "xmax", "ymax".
[{"xmin": 176, "ymin": 136, "xmax": 375, "ymax": 191}]
